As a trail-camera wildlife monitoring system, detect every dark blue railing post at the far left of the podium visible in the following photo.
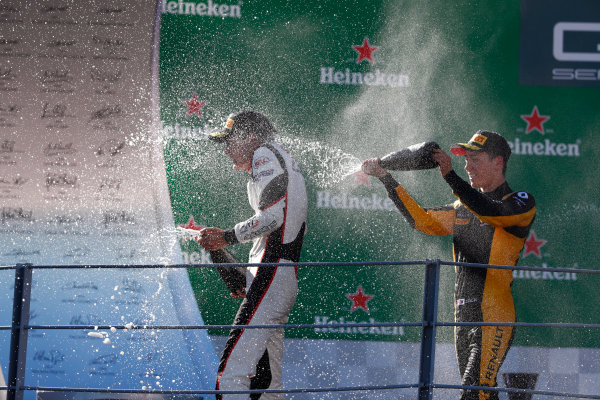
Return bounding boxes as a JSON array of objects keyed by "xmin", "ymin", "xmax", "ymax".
[{"xmin": 6, "ymin": 264, "xmax": 31, "ymax": 400}]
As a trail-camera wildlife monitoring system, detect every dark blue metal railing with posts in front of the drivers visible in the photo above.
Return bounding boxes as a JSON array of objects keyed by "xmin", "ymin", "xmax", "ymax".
[{"xmin": 0, "ymin": 260, "xmax": 600, "ymax": 400}]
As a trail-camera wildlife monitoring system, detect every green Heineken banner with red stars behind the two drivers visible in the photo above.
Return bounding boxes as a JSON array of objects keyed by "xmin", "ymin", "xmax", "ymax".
[{"xmin": 160, "ymin": 1, "xmax": 600, "ymax": 347}]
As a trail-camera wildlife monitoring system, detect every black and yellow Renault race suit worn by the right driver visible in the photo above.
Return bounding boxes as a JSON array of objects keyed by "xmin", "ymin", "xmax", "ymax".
[{"xmin": 381, "ymin": 171, "xmax": 536, "ymax": 400}]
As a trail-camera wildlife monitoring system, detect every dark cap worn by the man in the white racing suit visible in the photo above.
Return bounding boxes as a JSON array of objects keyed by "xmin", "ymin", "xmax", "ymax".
[{"xmin": 208, "ymin": 111, "xmax": 276, "ymax": 143}]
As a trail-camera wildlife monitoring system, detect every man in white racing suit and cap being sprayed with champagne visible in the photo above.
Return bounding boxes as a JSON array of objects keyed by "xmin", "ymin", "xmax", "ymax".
[{"xmin": 199, "ymin": 111, "xmax": 307, "ymax": 400}]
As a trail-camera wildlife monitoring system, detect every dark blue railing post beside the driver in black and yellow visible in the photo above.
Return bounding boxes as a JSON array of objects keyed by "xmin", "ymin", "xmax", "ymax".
[{"xmin": 419, "ymin": 260, "xmax": 440, "ymax": 400}]
